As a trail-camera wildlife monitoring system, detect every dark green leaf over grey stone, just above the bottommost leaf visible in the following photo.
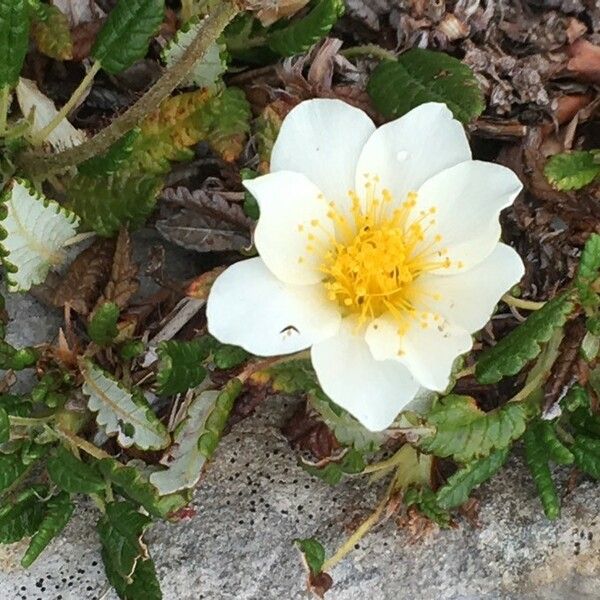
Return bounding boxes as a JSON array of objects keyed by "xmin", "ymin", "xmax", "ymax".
[{"xmin": 97, "ymin": 502, "xmax": 152, "ymax": 583}]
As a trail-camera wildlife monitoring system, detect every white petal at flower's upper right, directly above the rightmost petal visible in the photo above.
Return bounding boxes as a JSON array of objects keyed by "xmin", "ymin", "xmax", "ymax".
[{"xmin": 417, "ymin": 160, "xmax": 523, "ymax": 274}]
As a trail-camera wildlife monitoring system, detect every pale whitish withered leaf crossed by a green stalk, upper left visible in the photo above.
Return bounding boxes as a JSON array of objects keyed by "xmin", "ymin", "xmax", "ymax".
[{"xmin": 16, "ymin": 77, "xmax": 87, "ymax": 151}]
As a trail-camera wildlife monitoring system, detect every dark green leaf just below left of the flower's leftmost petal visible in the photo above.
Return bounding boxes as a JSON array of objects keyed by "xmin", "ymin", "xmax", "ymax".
[{"xmin": 156, "ymin": 337, "xmax": 214, "ymax": 396}]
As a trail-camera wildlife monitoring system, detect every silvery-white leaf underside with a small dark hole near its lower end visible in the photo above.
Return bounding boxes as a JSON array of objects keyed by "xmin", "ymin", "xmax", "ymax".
[{"xmin": 80, "ymin": 360, "xmax": 170, "ymax": 450}]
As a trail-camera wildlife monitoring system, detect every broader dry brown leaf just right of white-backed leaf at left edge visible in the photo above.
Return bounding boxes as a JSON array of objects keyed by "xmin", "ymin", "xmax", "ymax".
[{"xmin": 51, "ymin": 239, "xmax": 115, "ymax": 315}]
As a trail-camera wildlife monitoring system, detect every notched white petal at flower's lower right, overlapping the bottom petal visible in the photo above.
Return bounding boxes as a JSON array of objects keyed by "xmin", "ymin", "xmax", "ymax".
[{"xmin": 365, "ymin": 314, "xmax": 473, "ymax": 392}]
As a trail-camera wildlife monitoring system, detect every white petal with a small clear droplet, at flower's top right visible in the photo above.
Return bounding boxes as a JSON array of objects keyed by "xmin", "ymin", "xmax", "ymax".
[{"xmin": 356, "ymin": 102, "xmax": 471, "ymax": 202}]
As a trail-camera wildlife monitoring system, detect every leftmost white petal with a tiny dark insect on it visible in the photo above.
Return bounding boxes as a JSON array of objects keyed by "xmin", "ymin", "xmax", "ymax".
[{"xmin": 206, "ymin": 258, "xmax": 340, "ymax": 356}]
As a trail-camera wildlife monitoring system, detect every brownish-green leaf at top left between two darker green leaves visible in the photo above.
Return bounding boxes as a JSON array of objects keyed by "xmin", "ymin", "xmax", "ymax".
[{"xmin": 31, "ymin": 2, "xmax": 73, "ymax": 60}]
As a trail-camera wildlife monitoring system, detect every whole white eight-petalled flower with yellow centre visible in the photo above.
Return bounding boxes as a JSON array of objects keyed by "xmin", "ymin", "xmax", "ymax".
[{"xmin": 207, "ymin": 100, "xmax": 523, "ymax": 430}]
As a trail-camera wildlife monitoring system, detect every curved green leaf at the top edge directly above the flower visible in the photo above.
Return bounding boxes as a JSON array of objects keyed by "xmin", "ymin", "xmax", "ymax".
[{"xmin": 267, "ymin": 0, "xmax": 344, "ymax": 56}]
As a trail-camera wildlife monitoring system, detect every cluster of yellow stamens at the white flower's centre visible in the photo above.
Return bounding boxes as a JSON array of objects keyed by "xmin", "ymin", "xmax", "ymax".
[{"xmin": 302, "ymin": 177, "xmax": 462, "ymax": 334}]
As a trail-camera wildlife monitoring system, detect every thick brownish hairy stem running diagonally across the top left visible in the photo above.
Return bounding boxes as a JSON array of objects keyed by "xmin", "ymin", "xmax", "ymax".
[{"xmin": 17, "ymin": 0, "xmax": 240, "ymax": 179}]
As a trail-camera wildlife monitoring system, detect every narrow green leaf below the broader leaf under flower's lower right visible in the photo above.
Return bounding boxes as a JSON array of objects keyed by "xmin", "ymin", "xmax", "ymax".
[{"xmin": 436, "ymin": 448, "xmax": 509, "ymax": 510}]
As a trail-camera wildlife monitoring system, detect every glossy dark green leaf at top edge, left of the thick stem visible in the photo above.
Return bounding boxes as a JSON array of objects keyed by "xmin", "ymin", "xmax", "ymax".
[{"xmin": 91, "ymin": 0, "xmax": 165, "ymax": 75}]
